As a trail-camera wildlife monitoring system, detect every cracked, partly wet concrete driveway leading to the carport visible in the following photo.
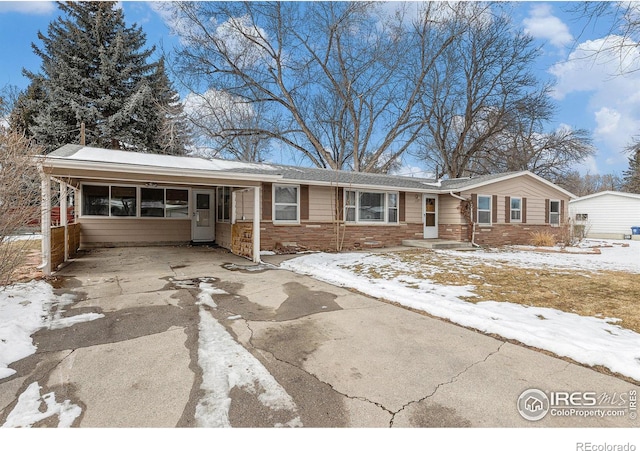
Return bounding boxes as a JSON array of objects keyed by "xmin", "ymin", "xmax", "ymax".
[{"xmin": 0, "ymin": 247, "xmax": 638, "ymax": 427}]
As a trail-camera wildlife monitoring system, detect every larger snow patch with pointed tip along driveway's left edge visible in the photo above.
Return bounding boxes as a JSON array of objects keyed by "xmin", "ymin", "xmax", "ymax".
[{"xmin": 0, "ymin": 280, "xmax": 104, "ymax": 379}]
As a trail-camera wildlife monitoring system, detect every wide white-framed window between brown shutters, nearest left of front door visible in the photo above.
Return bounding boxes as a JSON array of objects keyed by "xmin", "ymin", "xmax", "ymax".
[{"xmin": 344, "ymin": 190, "xmax": 399, "ymax": 224}]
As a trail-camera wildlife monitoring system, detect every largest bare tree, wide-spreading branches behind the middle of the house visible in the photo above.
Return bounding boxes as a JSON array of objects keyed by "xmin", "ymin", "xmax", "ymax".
[{"xmin": 162, "ymin": 2, "xmax": 467, "ymax": 172}]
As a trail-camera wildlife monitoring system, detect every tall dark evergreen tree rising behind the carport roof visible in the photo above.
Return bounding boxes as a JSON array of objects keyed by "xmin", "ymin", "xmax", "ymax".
[{"xmin": 23, "ymin": 1, "xmax": 188, "ymax": 154}]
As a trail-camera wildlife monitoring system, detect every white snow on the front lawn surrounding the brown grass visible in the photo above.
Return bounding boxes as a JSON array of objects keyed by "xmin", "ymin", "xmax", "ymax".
[{"xmin": 281, "ymin": 241, "xmax": 640, "ymax": 381}]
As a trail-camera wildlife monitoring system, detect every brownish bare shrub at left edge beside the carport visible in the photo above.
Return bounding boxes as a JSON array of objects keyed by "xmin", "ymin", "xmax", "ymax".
[{"xmin": 0, "ymin": 126, "xmax": 42, "ymax": 286}]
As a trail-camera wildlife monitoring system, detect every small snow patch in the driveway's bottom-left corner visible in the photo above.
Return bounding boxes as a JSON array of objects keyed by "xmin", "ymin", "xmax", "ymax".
[{"xmin": 2, "ymin": 382, "xmax": 82, "ymax": 428}]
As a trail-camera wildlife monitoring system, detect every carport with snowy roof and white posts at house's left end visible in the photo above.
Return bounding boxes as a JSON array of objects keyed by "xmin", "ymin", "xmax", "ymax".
[{"xmin": 40, "ymin": 145, "xmax": 281, "ymax": 275}]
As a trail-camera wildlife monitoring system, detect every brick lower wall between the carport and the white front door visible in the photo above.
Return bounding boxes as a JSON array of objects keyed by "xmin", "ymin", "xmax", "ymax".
[{"xmin": 260, "ymin": 222, "xmax": 423, "ymax": 251}]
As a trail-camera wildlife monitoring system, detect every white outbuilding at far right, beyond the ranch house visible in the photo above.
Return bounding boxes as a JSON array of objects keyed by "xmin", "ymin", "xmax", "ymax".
[{"xmin": 569, "ymin": 191, "xmax": 640, "ymax": 240}]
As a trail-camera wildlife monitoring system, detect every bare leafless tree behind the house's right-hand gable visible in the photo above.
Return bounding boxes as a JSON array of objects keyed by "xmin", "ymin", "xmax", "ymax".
[{"xmin": 422, "ymin": 3, "xmax": 593, "ymax": 178}]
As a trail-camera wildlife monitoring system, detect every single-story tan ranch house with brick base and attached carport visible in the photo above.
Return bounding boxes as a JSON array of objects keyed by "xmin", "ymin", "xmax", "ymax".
[{"xmin": 40, "ymin": 145, "xmax": 574, "ymax": 272}]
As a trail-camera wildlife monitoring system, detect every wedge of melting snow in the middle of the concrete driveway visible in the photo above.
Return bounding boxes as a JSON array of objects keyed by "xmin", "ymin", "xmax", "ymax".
[{"xmin": 186, "ymin": 279, "xmax": 302, "ymax": 427}]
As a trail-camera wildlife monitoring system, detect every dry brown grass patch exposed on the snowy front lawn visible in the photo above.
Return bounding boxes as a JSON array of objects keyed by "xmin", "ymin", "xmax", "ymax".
[{"xmin": 355, "ymin": 250, "xmax": 640, "ymax": 333}]
